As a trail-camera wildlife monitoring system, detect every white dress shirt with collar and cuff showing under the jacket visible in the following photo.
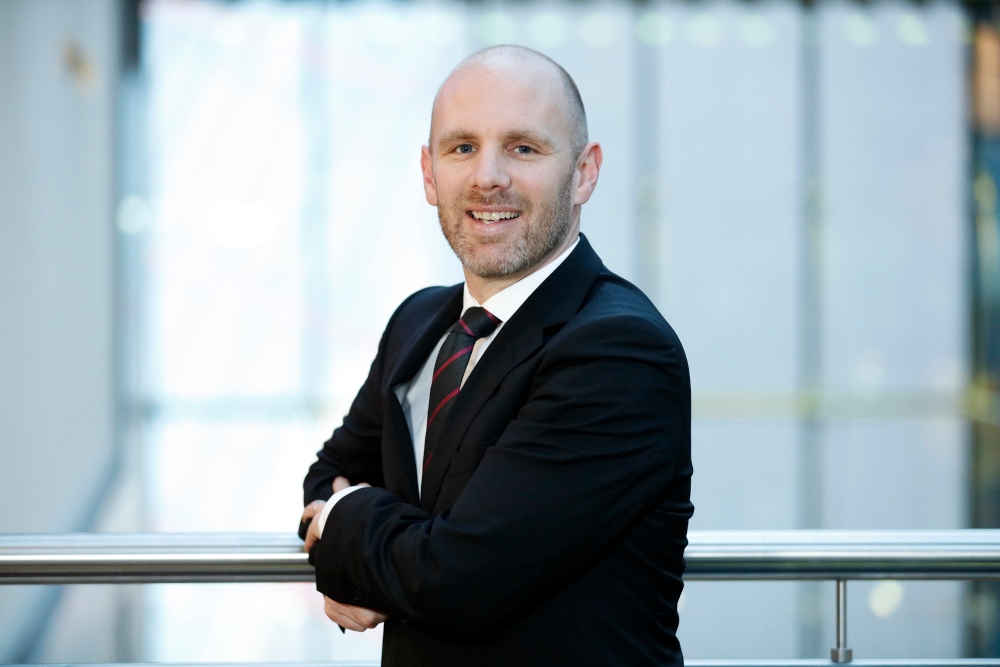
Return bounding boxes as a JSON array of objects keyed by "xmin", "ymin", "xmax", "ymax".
[{"xmin": 319, "ymin": 237, "xmax": 580, "ymax": 536}]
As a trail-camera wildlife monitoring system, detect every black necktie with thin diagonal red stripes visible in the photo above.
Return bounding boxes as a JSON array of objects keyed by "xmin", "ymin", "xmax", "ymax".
[{"xmin": 424, "ymin": 306, "xmax": 500, "ymax": 472}]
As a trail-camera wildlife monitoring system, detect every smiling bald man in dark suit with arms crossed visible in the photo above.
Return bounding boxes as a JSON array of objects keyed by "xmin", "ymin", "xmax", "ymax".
[{"xmin": 301, "ymin": 46, "xmax": 693, "ymax": 667}]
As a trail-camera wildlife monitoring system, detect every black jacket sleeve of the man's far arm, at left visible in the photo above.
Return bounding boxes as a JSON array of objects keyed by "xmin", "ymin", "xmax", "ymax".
[{"xmin": 299, "ymin": 295, "xmax": 415, "ymax": 539}]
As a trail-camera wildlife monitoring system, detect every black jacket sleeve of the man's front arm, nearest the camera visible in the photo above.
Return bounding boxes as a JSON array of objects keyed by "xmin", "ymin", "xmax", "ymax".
[{"xmin": 311, "ymin": 317, "xmax": 690, "ymax": 637}]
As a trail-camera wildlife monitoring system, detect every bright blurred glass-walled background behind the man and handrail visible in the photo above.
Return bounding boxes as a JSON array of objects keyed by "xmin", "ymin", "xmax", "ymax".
[{"xmin": 0, "ymin": 0, "xmax": 1000, "ymax": 662}]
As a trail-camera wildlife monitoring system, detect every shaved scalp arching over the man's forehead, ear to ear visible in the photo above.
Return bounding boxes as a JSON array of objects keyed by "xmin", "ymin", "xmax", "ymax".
[{"xmin": 431, "ymin": 44, "xmax": 588, "ymax": 158}]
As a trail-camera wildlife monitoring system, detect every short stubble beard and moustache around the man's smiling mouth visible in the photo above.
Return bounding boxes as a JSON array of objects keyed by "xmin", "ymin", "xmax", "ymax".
[{"xmin": 438, "ymin": 172, "xmax": 573, "ymax": 279}]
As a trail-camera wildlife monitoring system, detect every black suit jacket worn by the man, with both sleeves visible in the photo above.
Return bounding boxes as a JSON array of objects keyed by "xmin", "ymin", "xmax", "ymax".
[{"xmin": 305, "ymin": 237, "xmax": 693, "ymax": 667}]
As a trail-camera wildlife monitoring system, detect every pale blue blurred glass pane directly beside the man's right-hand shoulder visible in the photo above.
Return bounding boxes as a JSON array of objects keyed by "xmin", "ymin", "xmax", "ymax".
[{"xmin": 656, "ymin": 2, "xmax": 802, "ymax": 391}]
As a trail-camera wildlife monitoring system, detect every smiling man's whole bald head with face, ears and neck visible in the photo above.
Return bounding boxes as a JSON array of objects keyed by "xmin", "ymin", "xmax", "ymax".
[{"xmin": 420, "ymin": 46, "xmax": 604, "ymax": 294}]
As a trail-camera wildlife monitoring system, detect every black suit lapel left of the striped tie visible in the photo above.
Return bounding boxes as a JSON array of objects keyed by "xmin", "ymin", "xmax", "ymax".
[{"xmin": 382, "ymin": 285, "xmax": 462, "ymax": 505}]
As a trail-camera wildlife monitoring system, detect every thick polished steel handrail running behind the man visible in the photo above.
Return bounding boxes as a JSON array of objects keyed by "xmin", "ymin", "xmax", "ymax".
[{"xmin": 0, "ymin": 530, "xmax": 1000, "ymax": 584}]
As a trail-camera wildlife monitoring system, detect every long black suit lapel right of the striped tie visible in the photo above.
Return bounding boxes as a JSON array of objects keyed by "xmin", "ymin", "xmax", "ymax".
[{"xmin": 420, "ymin": 234, "xmax": 604, "ymax": 512}]
